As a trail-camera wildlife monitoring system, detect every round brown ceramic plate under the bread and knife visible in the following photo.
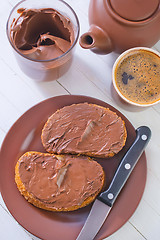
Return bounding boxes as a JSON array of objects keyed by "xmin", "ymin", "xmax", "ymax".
[{"xmin": 0, "ymin": 95, "xmax": 147, "ymax": 240}]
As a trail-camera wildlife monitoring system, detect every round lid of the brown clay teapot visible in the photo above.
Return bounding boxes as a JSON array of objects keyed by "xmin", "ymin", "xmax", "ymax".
[{"xmin": 109, "ymin": 0, "xmax": 159, "ymax": 21}]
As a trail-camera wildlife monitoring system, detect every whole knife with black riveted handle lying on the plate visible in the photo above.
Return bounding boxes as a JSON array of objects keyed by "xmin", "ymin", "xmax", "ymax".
[{"xmin": 76, "ymin": 126, "xmax": 151, "ymax": 240}]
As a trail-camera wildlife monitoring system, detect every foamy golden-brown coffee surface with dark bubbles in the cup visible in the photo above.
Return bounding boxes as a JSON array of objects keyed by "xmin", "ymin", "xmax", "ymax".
[{"xmin": 114, "ymin": 49, "xmax": 160, "ymax": 105}]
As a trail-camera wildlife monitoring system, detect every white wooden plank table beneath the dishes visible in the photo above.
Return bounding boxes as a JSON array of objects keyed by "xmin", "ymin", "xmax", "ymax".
[{"xmin": 0, "ymin": 0, "xmax": 160, "ymax": 240}]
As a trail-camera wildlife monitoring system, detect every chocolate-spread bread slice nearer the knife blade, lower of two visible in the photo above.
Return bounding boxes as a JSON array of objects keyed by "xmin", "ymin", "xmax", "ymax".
[{"xmin": 15, "ymin": 152, "xmax": 105, "ymax": 211}]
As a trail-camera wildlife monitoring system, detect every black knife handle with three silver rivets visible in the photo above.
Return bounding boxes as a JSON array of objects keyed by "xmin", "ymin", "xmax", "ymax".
[{"xmin": 98, "ymin": 126, "xmax": 151, "ymax": 207}]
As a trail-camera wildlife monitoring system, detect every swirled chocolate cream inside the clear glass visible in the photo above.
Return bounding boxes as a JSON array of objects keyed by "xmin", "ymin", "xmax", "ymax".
[{"xmin": 10, "ymin": 8, "xmax": 74, "ymax": 60}]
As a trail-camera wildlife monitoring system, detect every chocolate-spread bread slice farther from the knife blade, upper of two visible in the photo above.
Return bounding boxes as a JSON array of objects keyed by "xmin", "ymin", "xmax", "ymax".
[{"xmin": 41, "ymin": 103, "xmax": 127, "ymax": 158}]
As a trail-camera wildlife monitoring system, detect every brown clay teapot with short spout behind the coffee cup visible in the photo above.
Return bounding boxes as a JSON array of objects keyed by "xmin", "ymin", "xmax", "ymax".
[{"xmin": 80, "ymin": 0, "xmax": 160, "ymax": 54}]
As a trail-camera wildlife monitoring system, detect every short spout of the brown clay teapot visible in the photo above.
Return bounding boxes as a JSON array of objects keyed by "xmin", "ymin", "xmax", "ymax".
[{"xmin": 79, "ymin": 25, "xmax": 113, "ymax": 54}]
